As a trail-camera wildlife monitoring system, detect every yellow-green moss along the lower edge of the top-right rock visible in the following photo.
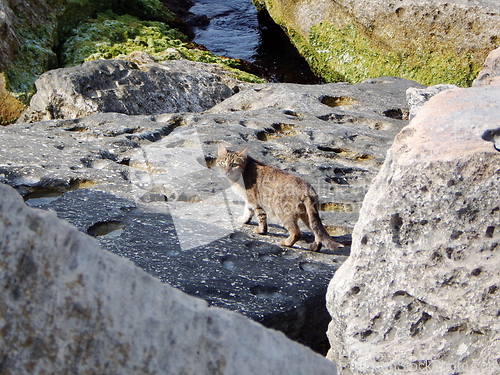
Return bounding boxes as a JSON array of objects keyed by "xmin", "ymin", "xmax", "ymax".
[{"xmin": 253, "ymin": 0, "xmax": 481, "ymax": 87}]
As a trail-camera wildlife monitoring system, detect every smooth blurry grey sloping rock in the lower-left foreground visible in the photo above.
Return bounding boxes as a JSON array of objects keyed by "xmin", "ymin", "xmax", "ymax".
[{"xmin": 0, "ymin": 184, "xmax": 336, "ymax": 375}]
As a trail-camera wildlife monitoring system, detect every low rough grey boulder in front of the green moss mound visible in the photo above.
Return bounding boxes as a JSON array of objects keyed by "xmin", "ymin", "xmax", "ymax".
[{"xmin": 19, "ymin": 58, "xmax": 237, "ymax": 122}]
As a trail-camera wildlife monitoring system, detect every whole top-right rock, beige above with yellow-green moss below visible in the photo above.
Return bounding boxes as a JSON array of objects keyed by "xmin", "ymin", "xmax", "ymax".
[{"xmin": 254, "ymin": 0, "xmax": 500, "ymax": 86}]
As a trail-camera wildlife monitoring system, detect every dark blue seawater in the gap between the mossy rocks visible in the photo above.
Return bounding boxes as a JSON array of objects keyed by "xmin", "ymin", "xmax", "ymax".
[{"xmin": 189, "ymin": 0, "xmax": 322, "ymax": 83}]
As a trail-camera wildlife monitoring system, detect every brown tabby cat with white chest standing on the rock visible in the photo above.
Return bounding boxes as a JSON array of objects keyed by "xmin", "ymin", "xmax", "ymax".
[{"xmin": 216, "ymin": 144, "xmax": 343, "ymax": 251}]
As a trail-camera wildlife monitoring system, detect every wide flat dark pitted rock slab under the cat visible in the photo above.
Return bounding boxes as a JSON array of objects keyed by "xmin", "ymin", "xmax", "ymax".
[{"xmin": 0, "ymin": 70, "xmax": 421, "ymax": 354}]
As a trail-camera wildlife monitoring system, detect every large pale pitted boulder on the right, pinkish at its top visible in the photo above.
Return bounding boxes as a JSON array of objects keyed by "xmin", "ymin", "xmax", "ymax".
[{"xmin": 327, "ymin": 55, "xmax": 500, "ymax": 375}]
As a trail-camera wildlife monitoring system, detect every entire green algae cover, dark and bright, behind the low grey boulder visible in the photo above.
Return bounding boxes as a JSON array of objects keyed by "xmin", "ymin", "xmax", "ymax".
[{"xmin": 0, "ymin": 0, "xmax": 262, "ymax": 104}]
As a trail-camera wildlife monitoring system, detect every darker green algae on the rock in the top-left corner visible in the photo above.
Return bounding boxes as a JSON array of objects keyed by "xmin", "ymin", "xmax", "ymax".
[{"xmin": 0, "ymin": 0, "xmax": 174, "ymax": 102}]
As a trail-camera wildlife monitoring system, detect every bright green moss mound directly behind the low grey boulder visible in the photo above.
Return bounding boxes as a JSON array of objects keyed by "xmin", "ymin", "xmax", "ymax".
[{"xmin": 60, "ymin": 11, "xmax": 264, "ymax": 82}]
